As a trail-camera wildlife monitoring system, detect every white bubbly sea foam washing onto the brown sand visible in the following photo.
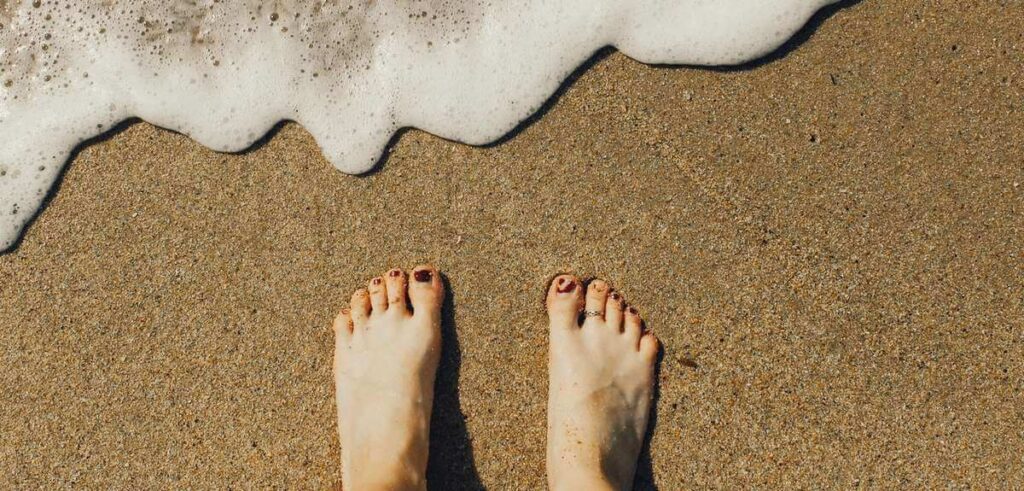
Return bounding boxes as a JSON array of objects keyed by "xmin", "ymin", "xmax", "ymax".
[{"xmin": 0, "ymin": 0, "xmax": 834, "ymax": 251}]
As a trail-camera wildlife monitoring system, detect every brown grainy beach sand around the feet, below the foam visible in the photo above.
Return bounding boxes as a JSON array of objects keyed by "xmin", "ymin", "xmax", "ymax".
[{"xmin": 0, "ymin": 0, "xmax": 1024, "ymax": 490}]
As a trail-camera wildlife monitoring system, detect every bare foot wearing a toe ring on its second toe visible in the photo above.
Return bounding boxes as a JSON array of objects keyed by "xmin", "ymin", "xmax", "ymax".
[{"xmin": 547, "ymin": 275, "xmax": 657, "ymax": 490}]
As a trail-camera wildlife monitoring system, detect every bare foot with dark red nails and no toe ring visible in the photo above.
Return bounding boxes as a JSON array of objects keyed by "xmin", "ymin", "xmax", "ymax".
[{"xmin": 334, "ymin": 265, "xmax": 444, "ymax": 491}]
